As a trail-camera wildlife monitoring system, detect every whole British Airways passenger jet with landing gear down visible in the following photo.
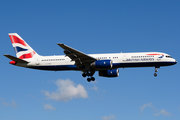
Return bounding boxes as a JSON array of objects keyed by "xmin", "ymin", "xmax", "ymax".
[{"xmin": 4, "ymin": 33, "xmax": 177, "ymax": 82}]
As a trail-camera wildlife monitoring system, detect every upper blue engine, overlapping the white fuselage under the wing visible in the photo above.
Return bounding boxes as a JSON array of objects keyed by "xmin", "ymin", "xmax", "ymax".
[{"xmin": 91, "ymin": 60, "xmax": 112, "ymax": 69}]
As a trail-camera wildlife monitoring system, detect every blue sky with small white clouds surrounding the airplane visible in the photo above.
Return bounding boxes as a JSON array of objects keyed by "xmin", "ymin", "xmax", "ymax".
[{"xmin": 0, "ymin": 0, "xmax": 180, "ymax": 120}]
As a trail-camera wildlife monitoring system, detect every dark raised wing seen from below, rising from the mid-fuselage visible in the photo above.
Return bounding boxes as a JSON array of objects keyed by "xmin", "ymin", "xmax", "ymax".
[{"xmin": 58, "ymin": 43, "xmax": 97, "ymax": 67}]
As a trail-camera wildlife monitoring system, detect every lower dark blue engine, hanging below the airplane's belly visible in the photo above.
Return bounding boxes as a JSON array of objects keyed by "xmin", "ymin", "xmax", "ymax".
[{"xmin": 99, "ymin": 69, "xmax": 119, "ymax": 77}]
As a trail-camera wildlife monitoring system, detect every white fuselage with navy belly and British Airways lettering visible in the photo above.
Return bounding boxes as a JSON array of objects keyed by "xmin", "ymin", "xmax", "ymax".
[{"xmin": 16, "ymin": 52, "xmax": 176, "ymax": 71}]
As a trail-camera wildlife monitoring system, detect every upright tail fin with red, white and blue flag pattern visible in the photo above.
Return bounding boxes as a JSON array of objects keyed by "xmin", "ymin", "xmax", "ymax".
[{"xmin": 9, "ymin": 33, "xmax": 38, "ymax": 59}]
